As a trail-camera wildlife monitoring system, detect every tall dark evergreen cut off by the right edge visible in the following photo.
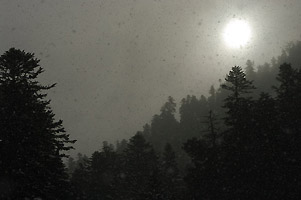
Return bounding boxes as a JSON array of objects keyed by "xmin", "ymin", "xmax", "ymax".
[{"xmin": 275, "ymin": 63, "xmax": 301, "ymax": 198}]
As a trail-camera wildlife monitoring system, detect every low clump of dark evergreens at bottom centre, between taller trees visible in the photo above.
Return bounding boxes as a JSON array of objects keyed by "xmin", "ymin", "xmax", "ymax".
[{"xmin": 71, "ymin": 132, "xmax": 185, "ymax": 200}]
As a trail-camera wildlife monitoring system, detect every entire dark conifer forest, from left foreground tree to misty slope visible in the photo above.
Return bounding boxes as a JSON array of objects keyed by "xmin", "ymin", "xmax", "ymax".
[{"xmin": 0, "ymin": 42, "xmax": 301, "ymax": 200}]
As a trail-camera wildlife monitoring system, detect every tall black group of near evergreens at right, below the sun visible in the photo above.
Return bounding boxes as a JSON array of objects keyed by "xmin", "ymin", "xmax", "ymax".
[{"xmin": 184, "ymin": 64, "xmax": 301, "ymax": 199}]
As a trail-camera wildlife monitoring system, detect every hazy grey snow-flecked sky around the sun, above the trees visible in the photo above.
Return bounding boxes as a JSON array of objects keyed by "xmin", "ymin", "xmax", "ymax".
[{"xmin": 0, "ymin": 0, "xmax": 301, "ymax": 154}]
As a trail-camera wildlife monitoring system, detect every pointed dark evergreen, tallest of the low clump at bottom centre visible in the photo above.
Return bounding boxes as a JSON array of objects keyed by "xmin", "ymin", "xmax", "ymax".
[{"xmin": 118, "ymin": 132, "xmax": 161, "ymax": 200}]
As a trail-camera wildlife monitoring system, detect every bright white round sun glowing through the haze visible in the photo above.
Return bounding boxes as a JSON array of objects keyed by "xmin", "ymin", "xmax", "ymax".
[{"xmin": 223, "ymin": 19, "xmax": 251, "ymax": 48}]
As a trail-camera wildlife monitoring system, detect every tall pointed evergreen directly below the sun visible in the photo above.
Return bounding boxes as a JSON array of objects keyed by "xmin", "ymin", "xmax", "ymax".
[{"xmin": 221, "ymin": 66, "xmax": 255, "ymax": 199}]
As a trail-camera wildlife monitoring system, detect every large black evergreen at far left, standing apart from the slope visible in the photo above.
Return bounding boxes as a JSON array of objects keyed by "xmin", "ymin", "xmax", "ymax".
[{"xmin": 0, "ymin": 48, "xmax": 74, "ymax": 199}]
